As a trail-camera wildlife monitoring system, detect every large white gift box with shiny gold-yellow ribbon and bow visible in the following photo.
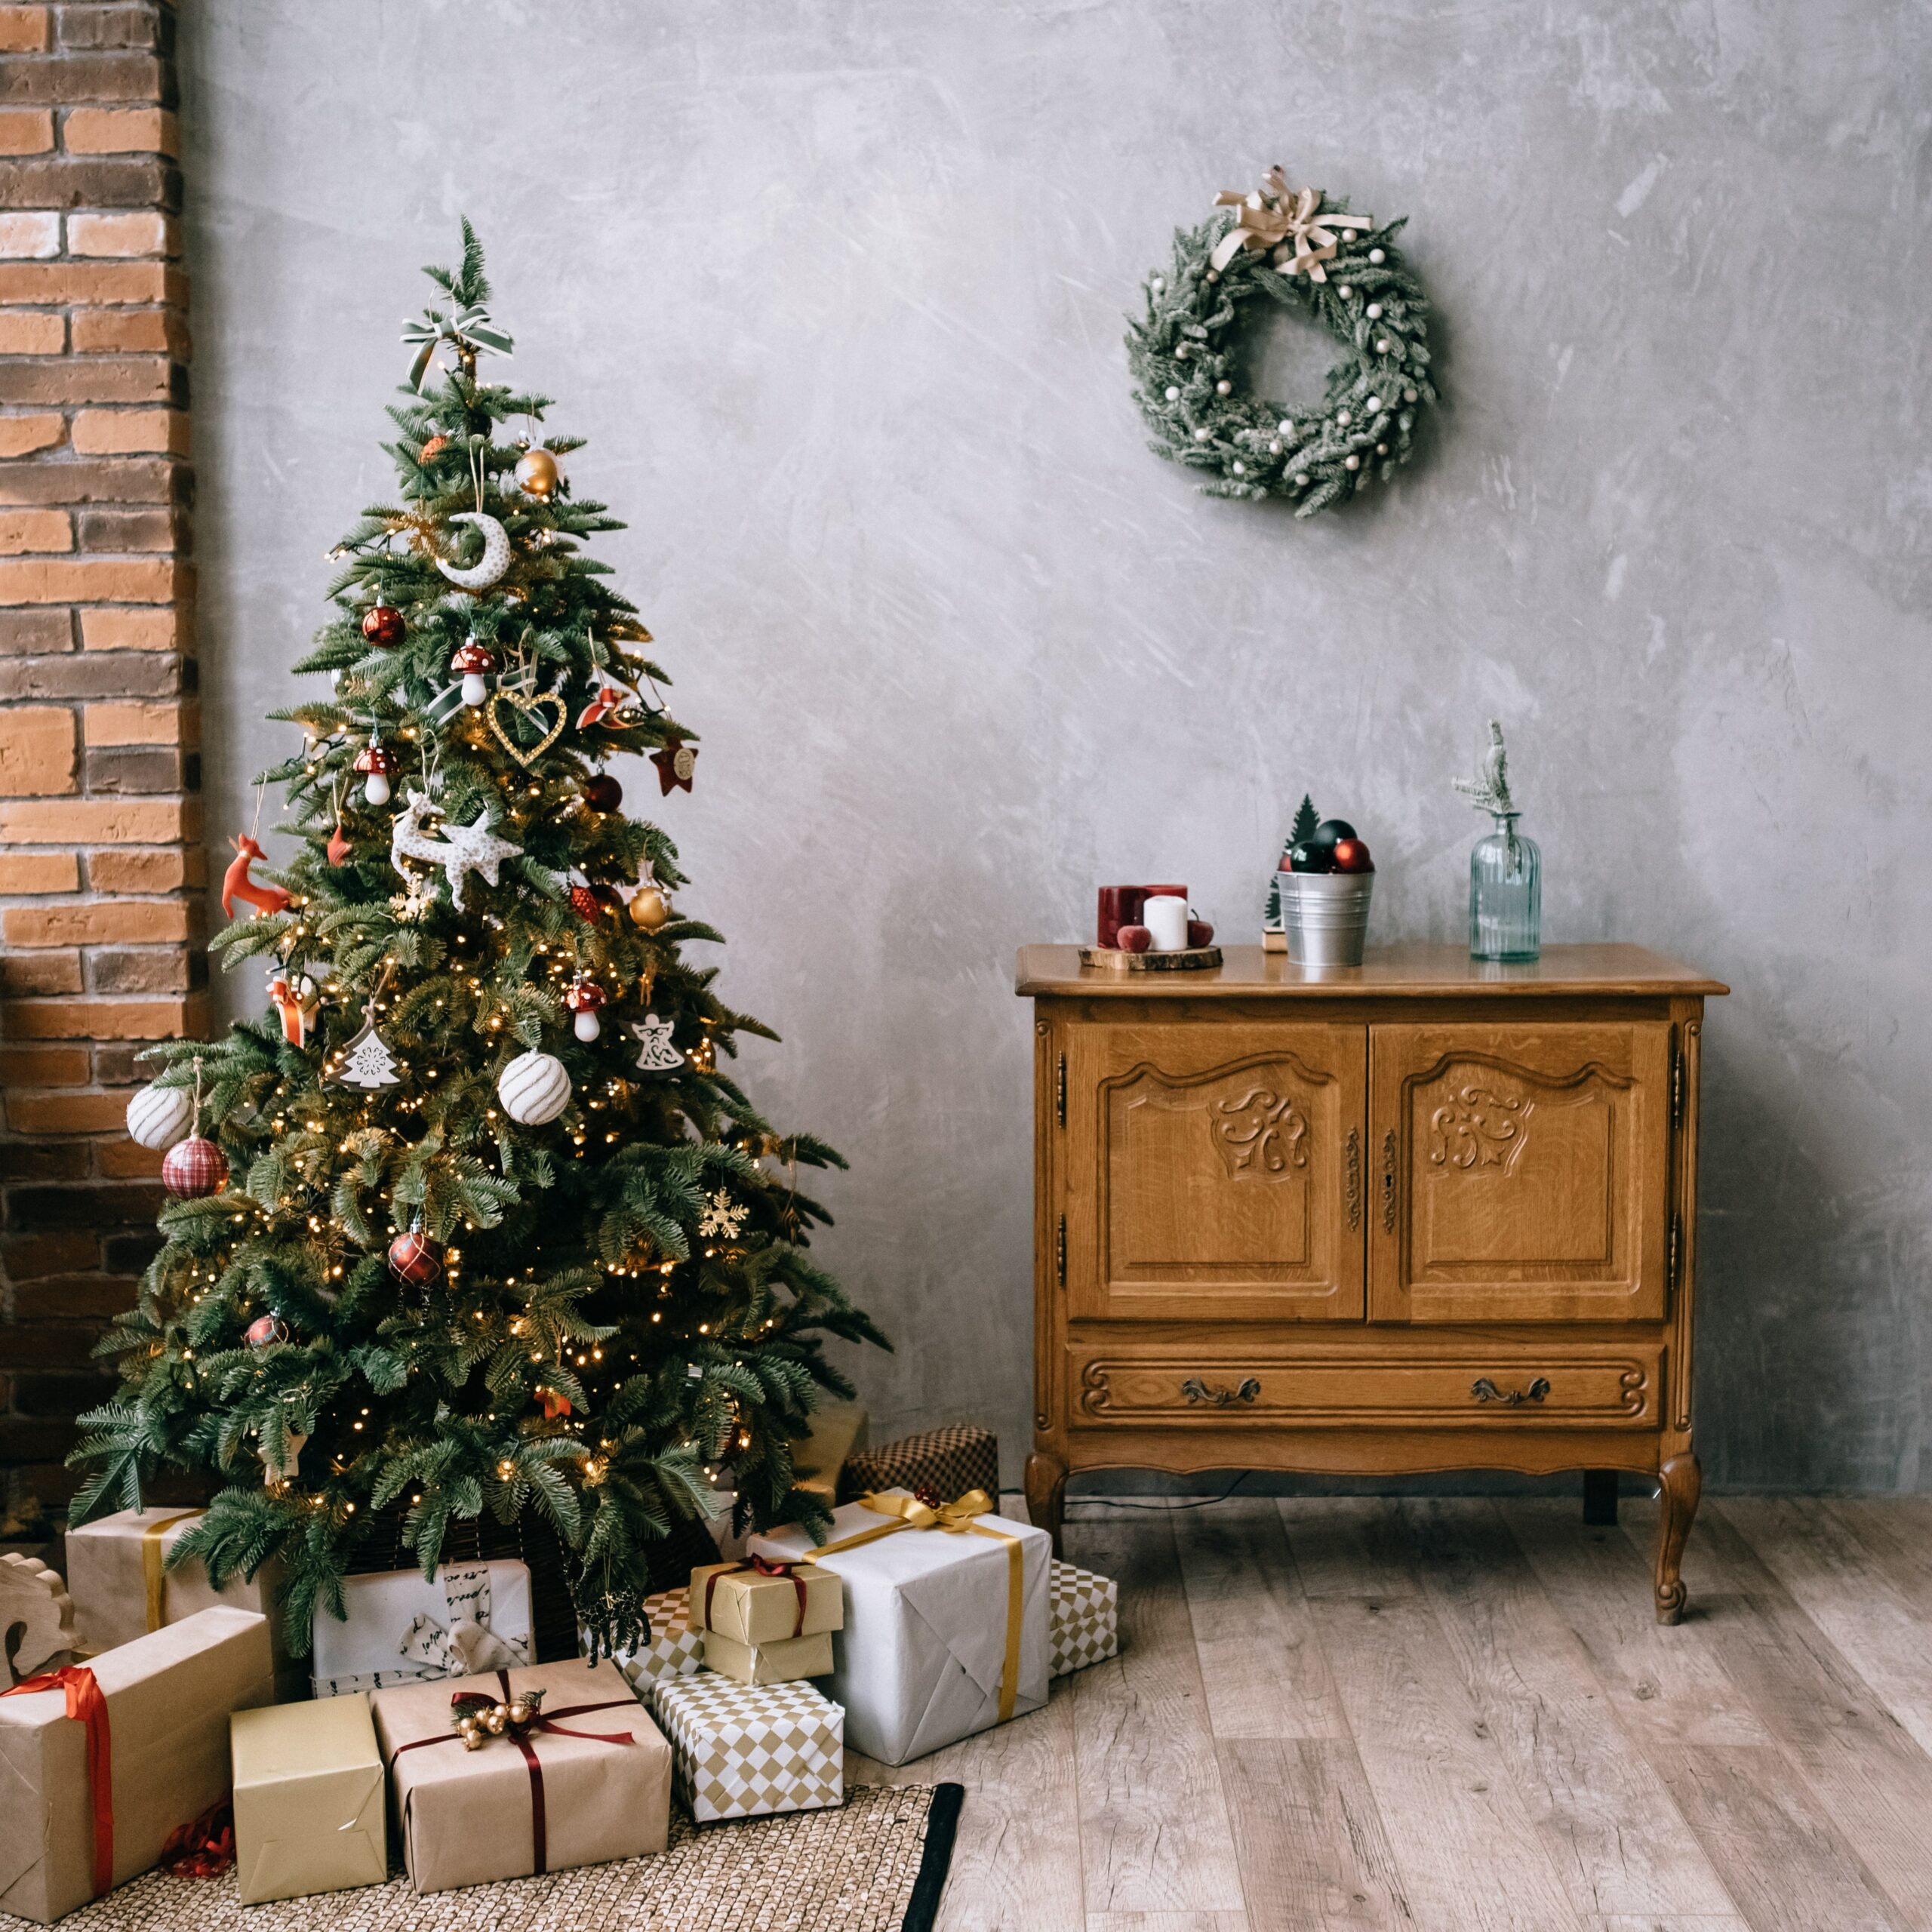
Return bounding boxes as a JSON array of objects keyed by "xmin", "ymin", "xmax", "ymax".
[{"xmin": 752, "ymin": 1491, "xmax": 1053, "ymax": 1764}]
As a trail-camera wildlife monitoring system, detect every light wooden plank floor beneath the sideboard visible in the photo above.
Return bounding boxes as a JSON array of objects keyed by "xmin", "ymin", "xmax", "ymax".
[{"xmin": 846, "ymin": 1497, "xmax": 1932, "ymax": 1932}]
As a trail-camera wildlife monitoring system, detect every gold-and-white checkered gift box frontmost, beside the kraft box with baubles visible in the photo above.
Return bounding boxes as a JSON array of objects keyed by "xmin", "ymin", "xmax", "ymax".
[{"xmin": 651, "ymin": 1671, "xmax": 844, "ymax": 1824}]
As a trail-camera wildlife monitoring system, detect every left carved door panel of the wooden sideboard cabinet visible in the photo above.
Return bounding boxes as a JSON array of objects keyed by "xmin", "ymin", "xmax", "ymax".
[{"xmin": 1066, "ymin": 1020, "xmax": 1367, "ymax": 1321}]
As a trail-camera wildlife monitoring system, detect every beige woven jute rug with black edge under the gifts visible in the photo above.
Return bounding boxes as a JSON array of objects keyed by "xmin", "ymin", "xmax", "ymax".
[{"xmin": 0, "ymin": 1785, "xmax": 960, "ymax": 1932}]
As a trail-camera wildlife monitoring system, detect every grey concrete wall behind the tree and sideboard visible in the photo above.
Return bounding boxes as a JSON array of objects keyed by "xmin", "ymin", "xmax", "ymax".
[{"xmin": 183, "ymin": 0, "xmax": 1932, "ymax": 1487}]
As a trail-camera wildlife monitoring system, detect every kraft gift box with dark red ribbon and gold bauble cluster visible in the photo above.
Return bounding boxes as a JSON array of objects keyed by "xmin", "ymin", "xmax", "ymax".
[{"xmin": 369, "ymin": 1662, "xmax": 670, "ymax": 1891}]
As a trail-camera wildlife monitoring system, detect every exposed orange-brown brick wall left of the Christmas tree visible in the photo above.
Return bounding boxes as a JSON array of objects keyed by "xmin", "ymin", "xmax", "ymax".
[{"xmin": 0, "ymin": 0, "xmax": 207, "ymax": 1509}]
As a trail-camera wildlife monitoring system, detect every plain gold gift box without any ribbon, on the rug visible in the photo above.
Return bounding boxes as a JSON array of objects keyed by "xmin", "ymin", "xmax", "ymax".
[{"xmin": 228, "ymin": 1697, "xmax": 389, "ymax": 1905}]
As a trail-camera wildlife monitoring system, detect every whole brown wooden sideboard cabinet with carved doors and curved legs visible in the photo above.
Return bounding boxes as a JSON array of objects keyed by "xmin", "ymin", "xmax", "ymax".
[{"xmin": 1018, "ymin": 945, "xmax": 1727, "ymax": 1623}]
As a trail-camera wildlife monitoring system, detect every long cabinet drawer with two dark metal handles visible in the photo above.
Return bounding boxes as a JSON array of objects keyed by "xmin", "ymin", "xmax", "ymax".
[{"xmin": 1070, "ymin": 1341, "xmax": 1663, "ymax": 1429}]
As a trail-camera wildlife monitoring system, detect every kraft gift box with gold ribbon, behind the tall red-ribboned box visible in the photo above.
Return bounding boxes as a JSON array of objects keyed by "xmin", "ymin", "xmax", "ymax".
[{"xmin": 68, "ymin": 1509, "xmax": 309, "ymax": 1697}]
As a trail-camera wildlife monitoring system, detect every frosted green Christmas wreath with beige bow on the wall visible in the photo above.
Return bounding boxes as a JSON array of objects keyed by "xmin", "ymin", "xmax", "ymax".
[{"xmin": 1126, "ymin": 168, "xmax": 1435, "ymax": 516}]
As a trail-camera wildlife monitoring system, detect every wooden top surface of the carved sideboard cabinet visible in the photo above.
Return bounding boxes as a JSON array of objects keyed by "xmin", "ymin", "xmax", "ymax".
[{"xmin": 1014, "ymin": 943, "xmax": 1731, "ymax": 999}]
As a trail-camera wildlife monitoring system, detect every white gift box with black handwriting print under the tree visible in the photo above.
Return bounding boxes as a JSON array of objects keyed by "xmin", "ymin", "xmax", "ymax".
[{"xmin": 313, "ymin": 1557, "xmax": 531, "ymax": 1697}]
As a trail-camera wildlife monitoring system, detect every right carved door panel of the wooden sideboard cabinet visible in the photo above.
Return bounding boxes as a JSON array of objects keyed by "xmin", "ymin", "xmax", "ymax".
[{"xmin": 1367, "ymin": 1020, "xmax": 1671, "ymax": 1321}]
